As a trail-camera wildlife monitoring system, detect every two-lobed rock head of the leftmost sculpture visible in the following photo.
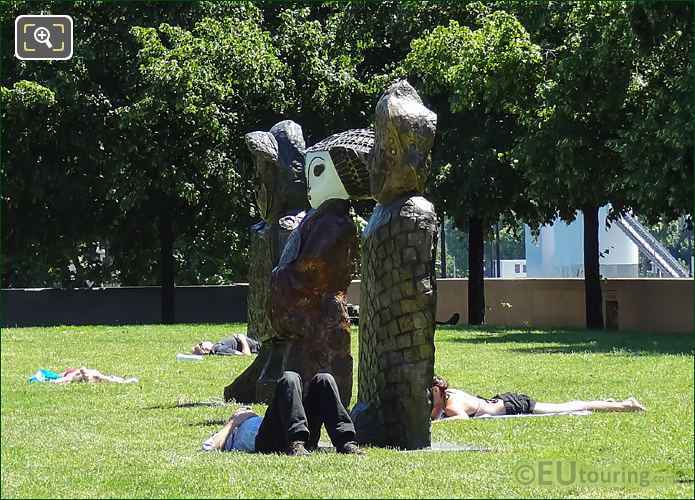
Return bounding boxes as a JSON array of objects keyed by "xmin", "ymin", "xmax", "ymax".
[{"xmin": 246, "ymin": 120, "xmax": 307, "ymax": 222}]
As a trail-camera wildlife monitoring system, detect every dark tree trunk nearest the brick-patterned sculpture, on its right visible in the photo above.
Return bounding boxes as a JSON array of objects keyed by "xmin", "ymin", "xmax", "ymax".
[{"xmin": 468, "ymin": 217, "xmax": 485, "ymax": 325}]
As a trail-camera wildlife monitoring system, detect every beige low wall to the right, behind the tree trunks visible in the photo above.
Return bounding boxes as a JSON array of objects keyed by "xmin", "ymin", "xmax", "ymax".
[{"xmin": 348, "ymin": 278, "xmax": 693, "ymax": 334}]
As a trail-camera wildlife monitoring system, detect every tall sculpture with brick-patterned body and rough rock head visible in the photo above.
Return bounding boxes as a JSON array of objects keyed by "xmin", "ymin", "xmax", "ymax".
[{"xmin": 352, "ymin": 80, "xmax": 437, "ymax": 449}]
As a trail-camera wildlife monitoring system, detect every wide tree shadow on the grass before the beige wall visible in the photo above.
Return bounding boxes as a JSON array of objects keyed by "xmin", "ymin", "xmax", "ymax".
[{"xmin": 438, "ymin": 325, "xmax": 693, "ymax": 356}]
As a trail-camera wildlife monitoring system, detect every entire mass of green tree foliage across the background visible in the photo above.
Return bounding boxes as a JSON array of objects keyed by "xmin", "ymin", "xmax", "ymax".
[{"xmin": 0, "ymin": 2, "xmax": 693, "ymax": 300}]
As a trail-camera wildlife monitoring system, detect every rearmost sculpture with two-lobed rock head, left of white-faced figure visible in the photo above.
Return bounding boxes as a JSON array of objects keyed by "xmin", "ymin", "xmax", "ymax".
[{"xmin": 224, "ymin": 120, "xmax": 308, "ymax": 403}]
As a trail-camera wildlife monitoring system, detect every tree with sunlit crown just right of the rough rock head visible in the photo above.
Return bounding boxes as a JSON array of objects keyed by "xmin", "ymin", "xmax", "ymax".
[{"xmin": 403, "ymin": 11, "xmax": 541, "ymax": 324}]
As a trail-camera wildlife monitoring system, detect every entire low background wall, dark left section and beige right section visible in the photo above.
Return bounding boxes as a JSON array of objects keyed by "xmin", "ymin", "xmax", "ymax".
[{"xmin": 1, "ymin": 278, "xmax": 693, "ymax": 334}]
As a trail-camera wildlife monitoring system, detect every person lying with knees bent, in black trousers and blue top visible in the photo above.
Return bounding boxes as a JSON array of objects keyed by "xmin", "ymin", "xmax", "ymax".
[{"xmin": 202, "ymin": 371, "xmax": 362, "ymax": 456}]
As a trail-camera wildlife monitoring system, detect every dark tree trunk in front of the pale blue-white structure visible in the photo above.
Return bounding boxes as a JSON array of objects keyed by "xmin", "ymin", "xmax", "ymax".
[{"xmin": 582, "ymin": 206, "xmax": 603, "ymax": 330}]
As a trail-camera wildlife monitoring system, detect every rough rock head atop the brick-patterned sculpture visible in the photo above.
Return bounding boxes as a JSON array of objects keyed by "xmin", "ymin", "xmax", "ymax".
[{"xmin": 369, "ymin": 80, "xmax": 437, "ymax": 204}]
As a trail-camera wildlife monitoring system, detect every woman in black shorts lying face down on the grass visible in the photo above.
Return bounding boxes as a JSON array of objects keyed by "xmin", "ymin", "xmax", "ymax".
[{"xmin": 431, "ymin": 375, "xmax": 646, "ymax": 420}]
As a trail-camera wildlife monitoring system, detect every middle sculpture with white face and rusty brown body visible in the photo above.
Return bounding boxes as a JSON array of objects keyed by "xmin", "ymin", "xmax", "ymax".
[{"xmin": 268, "ymin": 130, "xmax": 373, "ymax": 405}]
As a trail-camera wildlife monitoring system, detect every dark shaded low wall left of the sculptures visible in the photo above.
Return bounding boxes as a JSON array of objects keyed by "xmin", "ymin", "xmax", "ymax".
[{"xmin": 2, "ymin": 284, "xmax": 248, "ymax": 327}]
